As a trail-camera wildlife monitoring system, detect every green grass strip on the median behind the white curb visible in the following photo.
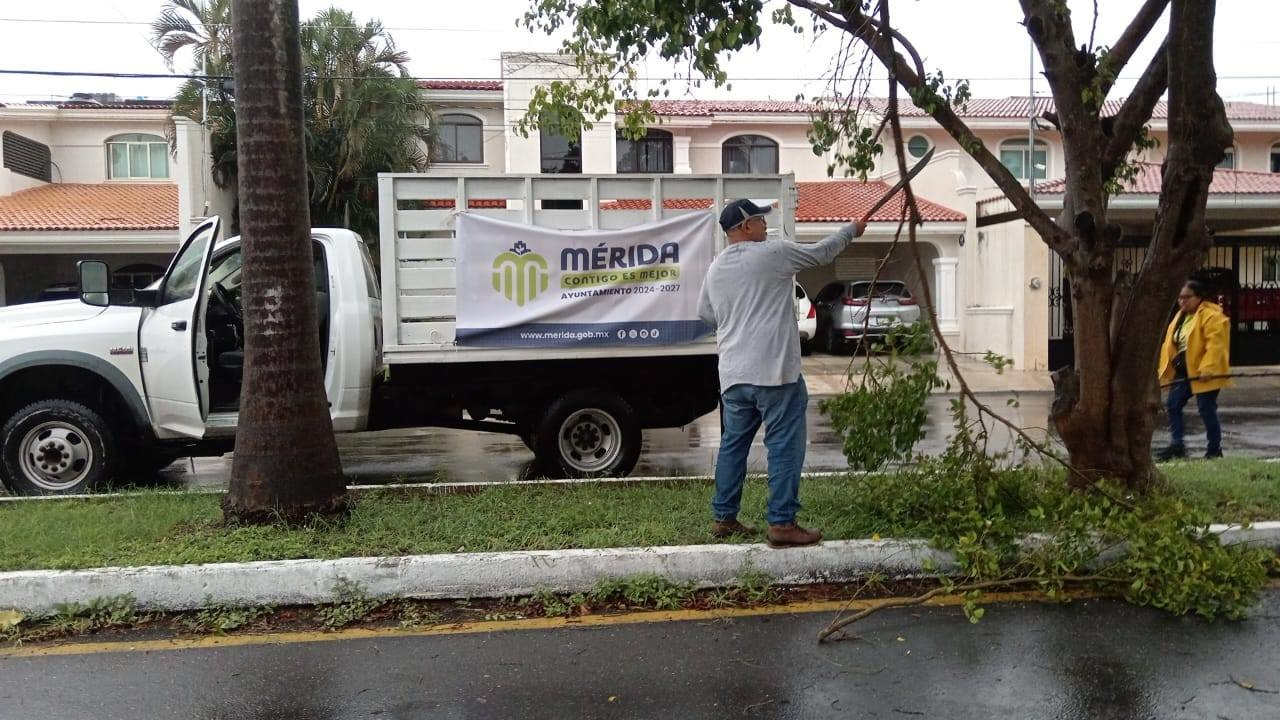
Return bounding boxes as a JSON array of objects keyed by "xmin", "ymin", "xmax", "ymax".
[{"xmin": 0, "ymin": 460, "xmax": 1280, "ymax": 570}]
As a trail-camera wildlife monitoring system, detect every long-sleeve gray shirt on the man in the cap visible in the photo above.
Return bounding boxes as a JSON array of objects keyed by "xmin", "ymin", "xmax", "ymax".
[{"xmin": 698, "ymin": 225, "xmax": 854, "ymax": 392}]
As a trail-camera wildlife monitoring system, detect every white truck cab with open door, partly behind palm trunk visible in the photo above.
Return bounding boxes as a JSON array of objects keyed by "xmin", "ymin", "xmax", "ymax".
[{"xmin": 0, "ymin": 218, "xmax": 381, "ymax": 495}]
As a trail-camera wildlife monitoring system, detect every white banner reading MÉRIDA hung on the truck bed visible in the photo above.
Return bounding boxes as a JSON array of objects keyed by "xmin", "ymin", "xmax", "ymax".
[{"xmin": 457, "ymin": 213, "xmax": 716, "ymax": 347}]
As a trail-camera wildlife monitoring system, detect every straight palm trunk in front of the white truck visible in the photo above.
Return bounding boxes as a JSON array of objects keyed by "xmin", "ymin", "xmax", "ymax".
[{"xmin": 223, "ymin": 0, "xmax": 347, "ymax": 523}]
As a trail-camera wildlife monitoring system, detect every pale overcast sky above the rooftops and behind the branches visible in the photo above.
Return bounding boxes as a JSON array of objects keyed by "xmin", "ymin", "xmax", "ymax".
[{"xmin": 0, "ymin": 0, "xmax": 1280, "ymax": 102}]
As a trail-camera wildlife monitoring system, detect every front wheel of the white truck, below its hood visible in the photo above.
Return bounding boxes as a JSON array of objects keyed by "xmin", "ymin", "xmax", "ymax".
[{"xmin": 0, "ymin": 400, "xmax": 115, "ymax": 495}]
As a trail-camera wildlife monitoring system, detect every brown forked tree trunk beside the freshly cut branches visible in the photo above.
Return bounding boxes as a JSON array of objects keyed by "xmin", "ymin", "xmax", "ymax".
[{"xmin": 1052, "ymin": 0, "xmax": 1231, "ymax": 492}]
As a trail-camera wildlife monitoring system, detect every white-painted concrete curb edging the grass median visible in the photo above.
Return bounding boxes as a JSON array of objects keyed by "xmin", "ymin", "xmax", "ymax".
[{"xmin": 0, "ymin": 521, "xmax": 1280, "ymax": 615}]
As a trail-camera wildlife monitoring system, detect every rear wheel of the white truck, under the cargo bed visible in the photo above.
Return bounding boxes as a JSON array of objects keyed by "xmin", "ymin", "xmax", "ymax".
[{"xmin": 534, "ymin": 389, "xmax": 643, "ymax": 478}]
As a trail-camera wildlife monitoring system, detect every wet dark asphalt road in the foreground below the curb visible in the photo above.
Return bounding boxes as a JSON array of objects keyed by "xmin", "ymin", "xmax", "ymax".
[{"xmin": 0, "ymin": 592, "xmax": 1280, "ymax": 720}]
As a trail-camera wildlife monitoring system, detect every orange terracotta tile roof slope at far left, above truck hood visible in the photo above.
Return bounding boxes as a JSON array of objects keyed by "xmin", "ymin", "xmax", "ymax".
[{"xmin": 0, "ymin": 183, "xmax": 178, "ymax": 232}]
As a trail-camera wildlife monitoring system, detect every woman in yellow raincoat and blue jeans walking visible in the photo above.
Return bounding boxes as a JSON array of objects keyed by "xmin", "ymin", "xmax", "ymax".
[{"xmin": 1156, "ymin": 281, "xmax": 1231, "ymax": 460}]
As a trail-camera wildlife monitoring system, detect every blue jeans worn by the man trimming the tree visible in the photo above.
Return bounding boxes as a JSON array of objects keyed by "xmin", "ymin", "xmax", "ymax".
[{"xmin": 712, "ymin": 378, "xmax": 809, "ymax": 525}]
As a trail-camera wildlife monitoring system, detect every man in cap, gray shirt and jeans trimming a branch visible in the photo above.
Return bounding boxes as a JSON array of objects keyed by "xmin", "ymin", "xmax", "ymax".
[{"xmin": 698, "ymin": 200, "xmax": 865, "ymax": 547}]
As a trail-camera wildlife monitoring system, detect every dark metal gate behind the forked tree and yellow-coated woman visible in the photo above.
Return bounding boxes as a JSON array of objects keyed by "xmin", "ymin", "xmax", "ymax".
[{"xmin": 1048, "ymin": 238, "xmax": 1280, "ymax": 370}]
